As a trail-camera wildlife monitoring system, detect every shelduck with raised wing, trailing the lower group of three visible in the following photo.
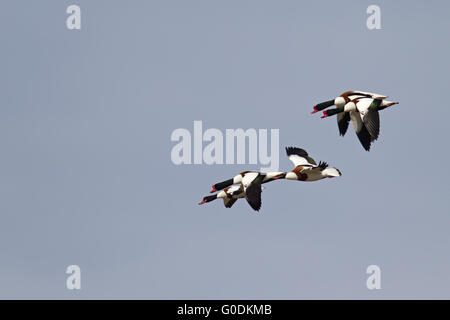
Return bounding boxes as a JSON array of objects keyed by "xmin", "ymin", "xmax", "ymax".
[{"xmin": 284, "ymin": 147, "xmax": 342, "ymax": 181}]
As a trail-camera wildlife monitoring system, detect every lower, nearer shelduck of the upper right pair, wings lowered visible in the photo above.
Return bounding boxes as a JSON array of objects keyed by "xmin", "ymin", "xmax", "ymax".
[{"xmin": 321, "ymin": 97, "xmax": 398, "ymax": 151}]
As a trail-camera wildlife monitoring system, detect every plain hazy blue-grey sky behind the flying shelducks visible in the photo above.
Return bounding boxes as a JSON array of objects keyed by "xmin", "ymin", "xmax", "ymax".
[{"xmin": 0, "ymin": 0, "xmax": 450, "ymax": 299}]
